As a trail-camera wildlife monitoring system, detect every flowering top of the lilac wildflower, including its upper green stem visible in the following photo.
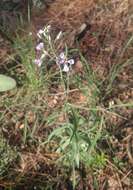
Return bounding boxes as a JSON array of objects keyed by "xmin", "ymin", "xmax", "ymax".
[{"xmin": 34, "ymin": 25, "xmax": 74, "ymax": 92}]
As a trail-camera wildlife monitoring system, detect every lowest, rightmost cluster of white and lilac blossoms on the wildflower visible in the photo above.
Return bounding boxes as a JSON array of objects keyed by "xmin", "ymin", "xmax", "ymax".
[{"xmin": 56, "ymin": 52, "xmax": 74, "ymax": 72}]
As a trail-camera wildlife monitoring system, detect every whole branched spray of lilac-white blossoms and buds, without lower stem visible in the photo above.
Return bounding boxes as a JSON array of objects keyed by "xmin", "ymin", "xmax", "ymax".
[{"xmin": 34, "ymin": 25, "xmax": 74, "ymax": 72}]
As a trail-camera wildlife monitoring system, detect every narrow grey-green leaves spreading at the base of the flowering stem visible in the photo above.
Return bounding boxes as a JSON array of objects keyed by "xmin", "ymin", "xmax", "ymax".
[{"xmin": 44, "ymin": 102, "xmax": 106, "ymax": 187}]
